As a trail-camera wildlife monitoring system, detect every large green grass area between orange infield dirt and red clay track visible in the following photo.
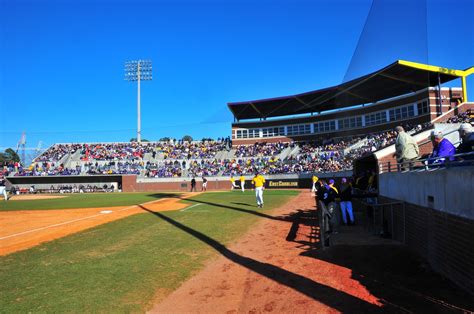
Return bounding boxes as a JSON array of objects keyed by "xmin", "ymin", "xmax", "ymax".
[{"xmin": 0, "ymin": 190, "xmax": 298, "ymax": 313}]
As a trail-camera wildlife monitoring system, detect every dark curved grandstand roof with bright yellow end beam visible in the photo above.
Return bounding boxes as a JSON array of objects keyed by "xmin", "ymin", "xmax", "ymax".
[{"xmin": 227, "ymin": 60, "xmax": 474, "ymax": 120}]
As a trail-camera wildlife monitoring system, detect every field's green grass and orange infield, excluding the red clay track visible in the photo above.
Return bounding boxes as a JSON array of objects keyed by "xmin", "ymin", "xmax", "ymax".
[{"xmin": 0, "ymin": 190, "xmax": 299, "ymax": 313}]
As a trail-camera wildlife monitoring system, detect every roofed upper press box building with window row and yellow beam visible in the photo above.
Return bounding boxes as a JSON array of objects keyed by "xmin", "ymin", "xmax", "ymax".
[{"xmin": 228, "ymin": 60, "xmax": 473, "ymax": 144}]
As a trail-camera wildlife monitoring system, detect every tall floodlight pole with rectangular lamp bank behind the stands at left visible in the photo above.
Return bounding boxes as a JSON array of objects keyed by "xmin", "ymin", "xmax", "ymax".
[{"xmin": 125, "ymin": 60, "xmax": 152, "ymax": 142}]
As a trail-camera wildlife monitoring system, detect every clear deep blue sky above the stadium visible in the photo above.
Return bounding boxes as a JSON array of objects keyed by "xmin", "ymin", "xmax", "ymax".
[{"xmin": 0, "ymin": 0, "xmax": 474, "ymax": 152}]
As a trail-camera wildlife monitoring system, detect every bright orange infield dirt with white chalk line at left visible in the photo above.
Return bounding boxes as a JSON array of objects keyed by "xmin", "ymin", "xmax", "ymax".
[{"xmin": 0, "ymin": 193, "xmax": 199, "ymax": 256}]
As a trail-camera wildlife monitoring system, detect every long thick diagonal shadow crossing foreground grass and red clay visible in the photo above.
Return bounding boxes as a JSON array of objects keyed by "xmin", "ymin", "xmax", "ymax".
[{"xmin": 141, "ymin": 206, "xmax": 381, "ymax": 312}]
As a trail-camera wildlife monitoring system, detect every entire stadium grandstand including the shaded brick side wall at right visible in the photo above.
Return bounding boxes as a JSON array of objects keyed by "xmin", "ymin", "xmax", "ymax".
[{"xmin": 0, "ymin": 61, "xmax": 474, "ymax": 300}]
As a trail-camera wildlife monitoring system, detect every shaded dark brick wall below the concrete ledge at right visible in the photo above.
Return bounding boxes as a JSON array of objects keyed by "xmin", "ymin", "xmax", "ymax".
[{"xmin": 364, "ymin": 197, "xmax": 474, "ymax": 294}]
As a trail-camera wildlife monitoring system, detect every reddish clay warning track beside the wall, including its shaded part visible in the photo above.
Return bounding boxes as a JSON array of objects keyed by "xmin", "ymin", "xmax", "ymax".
[{"xmin": 150, "ymin": 191, "xmax": 474, "ymax": 313}]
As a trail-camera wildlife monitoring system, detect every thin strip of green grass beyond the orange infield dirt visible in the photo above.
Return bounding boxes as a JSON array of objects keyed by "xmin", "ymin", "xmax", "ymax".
[{"xmin": 0, "ymin": 193, "xmax": 179, "ymax": 211}]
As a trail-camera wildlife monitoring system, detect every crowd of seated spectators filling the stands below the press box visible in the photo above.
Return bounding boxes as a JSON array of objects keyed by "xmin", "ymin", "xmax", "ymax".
[{"xmin": 2, "ymin": 119, "xmax": 462, "ymax": 178}]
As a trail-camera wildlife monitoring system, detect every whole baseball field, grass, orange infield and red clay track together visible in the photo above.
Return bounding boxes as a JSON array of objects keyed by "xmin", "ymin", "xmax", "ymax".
[{"xmin": 0, "ymin": 190, "xmax": 474, "ymax": 313}]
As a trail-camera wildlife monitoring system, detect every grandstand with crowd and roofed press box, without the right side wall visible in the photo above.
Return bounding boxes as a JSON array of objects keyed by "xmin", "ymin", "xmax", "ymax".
[{"xmin": 2, "ymin": 60, "xmax": 474, "ymax": 191}]
